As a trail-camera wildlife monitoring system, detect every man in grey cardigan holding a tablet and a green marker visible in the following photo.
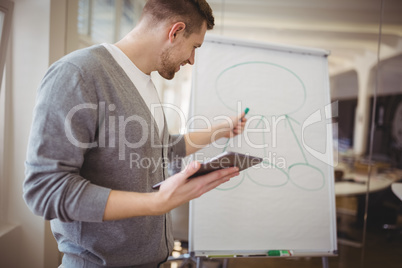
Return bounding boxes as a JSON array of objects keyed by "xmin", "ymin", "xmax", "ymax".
[{"xmin": 24, "ymin": 0, "xmax": 245, "ymax": 268}]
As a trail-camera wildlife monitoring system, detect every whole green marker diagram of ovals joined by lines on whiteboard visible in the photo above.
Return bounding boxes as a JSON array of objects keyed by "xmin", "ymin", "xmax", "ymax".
[{"xmin": 215, "ymin": 61, "xmax": 325, "ymax": 191}]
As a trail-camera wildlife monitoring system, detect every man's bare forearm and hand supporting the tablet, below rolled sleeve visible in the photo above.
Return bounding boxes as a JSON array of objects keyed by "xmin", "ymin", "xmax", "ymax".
[{"xmin": 103, "ymin": 161, "xmax": 239, "ymax": 221}]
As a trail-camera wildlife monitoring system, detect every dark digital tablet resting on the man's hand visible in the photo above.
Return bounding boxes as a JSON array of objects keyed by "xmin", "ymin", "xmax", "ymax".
[{"xmin": 152, "ymin": 152, "xmax": 263, "ymax": 189}]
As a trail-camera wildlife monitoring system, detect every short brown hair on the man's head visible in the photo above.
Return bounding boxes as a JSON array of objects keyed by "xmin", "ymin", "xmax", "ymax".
[{"xmin": 141, "ymin": 0, "xmax": 215, "ymax": 37}]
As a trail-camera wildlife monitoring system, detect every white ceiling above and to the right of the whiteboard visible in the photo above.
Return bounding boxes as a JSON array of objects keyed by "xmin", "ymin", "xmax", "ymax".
[{"xmin": 208, "ymin": 0, "xmax": 402, "ymax": 75}]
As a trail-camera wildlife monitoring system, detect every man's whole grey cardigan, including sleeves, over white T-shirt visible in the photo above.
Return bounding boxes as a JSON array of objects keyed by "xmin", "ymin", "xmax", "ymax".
[{"xmin": 23, "ymin": 45, "xmax": 185, "ymax": 268}]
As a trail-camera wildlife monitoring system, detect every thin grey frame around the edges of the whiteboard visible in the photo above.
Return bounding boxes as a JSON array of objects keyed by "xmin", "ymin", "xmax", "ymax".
[{"xmin": 188, "ymin": 34, "xmax": 338, "ymax": 258}]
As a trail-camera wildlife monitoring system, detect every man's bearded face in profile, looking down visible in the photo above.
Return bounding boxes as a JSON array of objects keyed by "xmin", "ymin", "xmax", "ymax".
[{"xmin": 158, "ymin": 23, "xmax": 207, "ymax": 80}]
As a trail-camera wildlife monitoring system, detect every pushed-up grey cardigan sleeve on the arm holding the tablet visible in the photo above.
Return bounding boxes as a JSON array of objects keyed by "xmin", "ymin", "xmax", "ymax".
[{"xmin": 23, "ymin": 61, "xmax": 110, "ymax": 222}]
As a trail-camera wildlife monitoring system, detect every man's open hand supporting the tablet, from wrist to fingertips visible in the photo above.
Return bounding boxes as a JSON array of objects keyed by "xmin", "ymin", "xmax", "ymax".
[{"xmin": 155, "ymin": 161, "xmax": 239, "ymax": 214}]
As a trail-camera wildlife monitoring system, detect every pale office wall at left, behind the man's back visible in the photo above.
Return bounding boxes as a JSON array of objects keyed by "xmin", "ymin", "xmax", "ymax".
[{"xmin": 0, "ymin": 0, "xmax": 67, "ymax": 268}]
